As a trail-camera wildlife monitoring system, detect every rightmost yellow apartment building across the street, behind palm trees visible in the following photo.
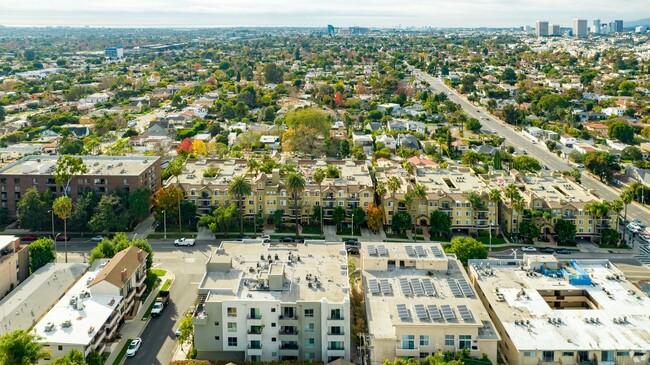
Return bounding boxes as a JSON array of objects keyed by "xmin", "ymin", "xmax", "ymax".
[{"xmin": 482, "ymin": 170, "xmax": 617, "ymax": 239}]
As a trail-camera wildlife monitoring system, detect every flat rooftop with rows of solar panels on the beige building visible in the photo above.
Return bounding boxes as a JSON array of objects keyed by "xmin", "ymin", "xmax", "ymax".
[{"xmin": 361, "ymin": 242, "xmax": 499, "ymax": 340}]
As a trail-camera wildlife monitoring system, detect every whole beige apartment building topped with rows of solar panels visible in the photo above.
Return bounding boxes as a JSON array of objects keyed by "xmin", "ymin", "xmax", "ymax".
[{"xmin": 361, "ymin": 242, "xmax": 500, "ymax": 364}]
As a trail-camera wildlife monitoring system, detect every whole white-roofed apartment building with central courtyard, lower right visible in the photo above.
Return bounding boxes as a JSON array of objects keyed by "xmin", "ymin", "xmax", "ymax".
[{"xmin": 469, "ymin": 255, "xmax": 650, "ymax": 365}]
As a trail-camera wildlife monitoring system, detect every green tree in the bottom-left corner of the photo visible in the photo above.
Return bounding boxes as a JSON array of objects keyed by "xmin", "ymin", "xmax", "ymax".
[{"xmin": 0, "ymin": 330, "xmax": 50, "ymax": 365}]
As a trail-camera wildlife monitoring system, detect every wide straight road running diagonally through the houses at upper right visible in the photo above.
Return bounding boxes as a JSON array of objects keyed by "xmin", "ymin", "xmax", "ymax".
[{"xmin": 413, "ymin": 70, "xmax": 650, "ymax": 223}]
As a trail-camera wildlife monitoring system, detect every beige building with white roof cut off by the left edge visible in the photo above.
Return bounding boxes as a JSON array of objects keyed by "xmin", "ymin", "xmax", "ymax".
[{"xmin": 0, "ymin": 235, "xmax": 29, "ymax": 302}]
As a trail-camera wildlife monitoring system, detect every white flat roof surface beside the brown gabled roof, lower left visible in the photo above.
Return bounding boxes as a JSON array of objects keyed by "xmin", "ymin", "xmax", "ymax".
[{"xmin": 34, "ymin": 267, "xmax": 122, "ymax": 345}]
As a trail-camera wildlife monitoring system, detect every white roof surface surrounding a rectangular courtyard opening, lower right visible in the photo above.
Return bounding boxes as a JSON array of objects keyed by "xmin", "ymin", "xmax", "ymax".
[{"xmin": 471, "ymin": 256, "xmax": 650, "ymax": 351}]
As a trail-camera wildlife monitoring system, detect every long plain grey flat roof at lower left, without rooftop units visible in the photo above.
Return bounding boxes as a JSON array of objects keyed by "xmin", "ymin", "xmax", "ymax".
[{"xmin": 0, "ymin": 263, "xmax": 88, "ymax": 333}]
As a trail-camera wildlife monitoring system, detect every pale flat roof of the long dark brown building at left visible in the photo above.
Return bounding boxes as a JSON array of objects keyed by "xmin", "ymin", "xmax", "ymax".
[{"xmin": 0, "ymin": 155, "xmax": 160, "ymax": 176}]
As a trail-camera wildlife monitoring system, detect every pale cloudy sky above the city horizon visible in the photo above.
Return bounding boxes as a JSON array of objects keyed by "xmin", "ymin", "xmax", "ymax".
[{"xmin": 0, "ymin": 0, "xmax": 650, "ymax": 27}]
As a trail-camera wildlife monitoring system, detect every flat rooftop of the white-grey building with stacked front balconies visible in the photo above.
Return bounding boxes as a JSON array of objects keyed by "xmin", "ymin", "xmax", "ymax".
[{"xmin": 199, "ymin": 240, "xmax": 349, "ymax": 302}]
